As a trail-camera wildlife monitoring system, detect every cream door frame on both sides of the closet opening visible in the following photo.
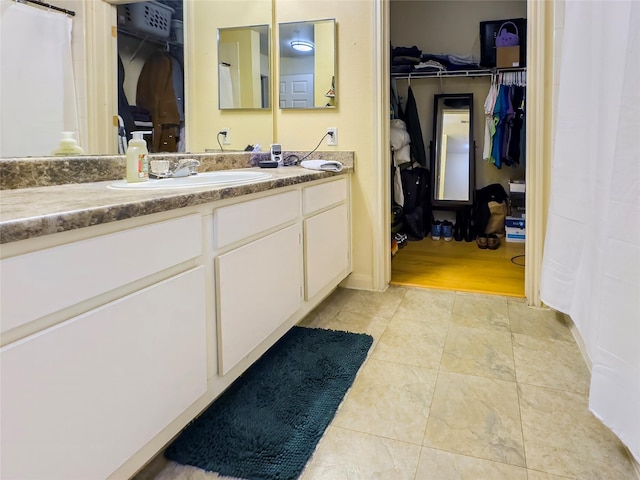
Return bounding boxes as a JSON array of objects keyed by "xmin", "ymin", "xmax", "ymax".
[{"xmin": 373, "ymin": 0, "xmax": 555, "ymax": 306}]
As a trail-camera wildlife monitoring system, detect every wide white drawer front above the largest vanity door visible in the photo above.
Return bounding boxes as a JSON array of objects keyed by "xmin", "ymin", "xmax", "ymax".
[{"xmin": 0, "ymin": 215, "xmax": 202, "ymax": 332}]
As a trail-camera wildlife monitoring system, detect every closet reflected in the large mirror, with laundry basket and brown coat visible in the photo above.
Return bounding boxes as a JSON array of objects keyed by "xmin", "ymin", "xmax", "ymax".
[{"xmin": 117, "ymin": 0, "xmax": 185, "ymax": 153}]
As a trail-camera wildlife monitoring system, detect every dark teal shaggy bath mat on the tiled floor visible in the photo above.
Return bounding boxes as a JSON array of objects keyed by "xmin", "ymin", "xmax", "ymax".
[{"xmin": 165, "ymin": 327, "xmax": 373, "ymax": 480}]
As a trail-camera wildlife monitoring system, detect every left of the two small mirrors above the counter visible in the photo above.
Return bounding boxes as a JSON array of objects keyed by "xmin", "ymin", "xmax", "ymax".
[{"xmin": 218, "ymin": 25, "xmax": 271, "ymax": 110}]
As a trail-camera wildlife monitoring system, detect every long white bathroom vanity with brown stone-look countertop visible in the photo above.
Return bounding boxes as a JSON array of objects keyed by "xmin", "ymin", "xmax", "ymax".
[{"xmin": 0, "ymin": 156, "xmax": 352, "ymax": 479}]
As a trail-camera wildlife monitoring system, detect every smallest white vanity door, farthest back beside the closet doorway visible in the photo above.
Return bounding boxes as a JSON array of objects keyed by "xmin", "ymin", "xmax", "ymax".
[{"xmin": 304, "ymin": 204, "xmax": 349, "ymax": 300}]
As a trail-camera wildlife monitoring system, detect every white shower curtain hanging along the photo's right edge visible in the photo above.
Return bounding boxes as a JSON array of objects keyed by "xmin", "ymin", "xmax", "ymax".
[{"xmin": 540, "ymin": 0, "xmax": 640, "ymax": 461}]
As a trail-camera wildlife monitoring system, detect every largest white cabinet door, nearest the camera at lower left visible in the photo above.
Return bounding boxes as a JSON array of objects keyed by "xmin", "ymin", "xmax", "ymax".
[{"xmin": 0, "ymin": 267, "xmax": 207, "ymax": 479}]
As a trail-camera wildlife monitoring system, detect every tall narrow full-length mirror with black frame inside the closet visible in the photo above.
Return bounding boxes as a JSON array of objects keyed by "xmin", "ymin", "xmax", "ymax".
[{"xmin": 431, "ymin": 93, "xmax": 475, "ymax": 207}]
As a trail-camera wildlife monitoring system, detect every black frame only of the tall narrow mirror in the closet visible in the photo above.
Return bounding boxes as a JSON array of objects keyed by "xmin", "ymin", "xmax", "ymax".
[{"xmin": 431, "ymin": 93, "xmax": 476, "ymax": 208}]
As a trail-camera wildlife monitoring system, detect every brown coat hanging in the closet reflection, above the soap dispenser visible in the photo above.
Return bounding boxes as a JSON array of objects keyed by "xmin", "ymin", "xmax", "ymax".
[{"xmin": 136, "ymin": 52, "xmax": 180, "ymax": 152}]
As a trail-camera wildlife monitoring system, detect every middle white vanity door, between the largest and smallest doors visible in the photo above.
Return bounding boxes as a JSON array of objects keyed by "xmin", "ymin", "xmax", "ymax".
[{"xmin": 216, "ymin": 225, "xmax": 302, "ymax": 375}]
